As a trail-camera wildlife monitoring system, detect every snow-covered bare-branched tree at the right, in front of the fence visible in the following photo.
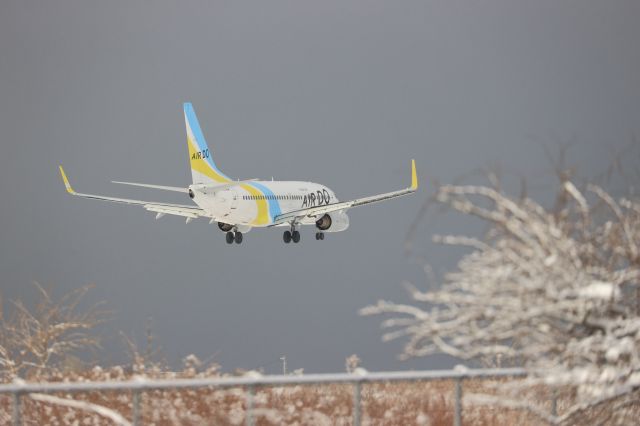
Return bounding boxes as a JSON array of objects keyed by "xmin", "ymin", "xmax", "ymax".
[{"xmin": 361, "ymin": 179, "xmax": 640, "ymax": 423}]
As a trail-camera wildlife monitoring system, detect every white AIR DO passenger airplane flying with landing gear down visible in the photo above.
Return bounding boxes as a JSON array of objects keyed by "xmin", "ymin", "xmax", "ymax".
[{"xmin": 60, "ymin": 102, "xmax": 418, "ymax": 244}]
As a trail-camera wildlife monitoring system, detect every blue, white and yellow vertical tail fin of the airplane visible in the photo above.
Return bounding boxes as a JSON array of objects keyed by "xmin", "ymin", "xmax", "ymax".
[{"xmin": 184, "ymin": 102, "xmax": 231, "ymax": 184}]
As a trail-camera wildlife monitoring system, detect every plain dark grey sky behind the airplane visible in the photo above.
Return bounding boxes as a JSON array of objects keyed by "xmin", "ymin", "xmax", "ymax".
[{"xmin": 0, "ymin": 0, "xmax": 640, "ymax": 372}]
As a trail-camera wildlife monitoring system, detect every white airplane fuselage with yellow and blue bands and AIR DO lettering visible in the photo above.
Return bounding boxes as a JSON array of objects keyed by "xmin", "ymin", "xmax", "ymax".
[{"xmin": 189, "ymin": 181, "xmax": 348, "ymax": 232}]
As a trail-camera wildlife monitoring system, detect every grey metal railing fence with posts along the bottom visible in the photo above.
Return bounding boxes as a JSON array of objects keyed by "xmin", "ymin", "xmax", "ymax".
[{"xmin": 0, "ymin": 368, "xmax": 526, "ymax": 426}]
